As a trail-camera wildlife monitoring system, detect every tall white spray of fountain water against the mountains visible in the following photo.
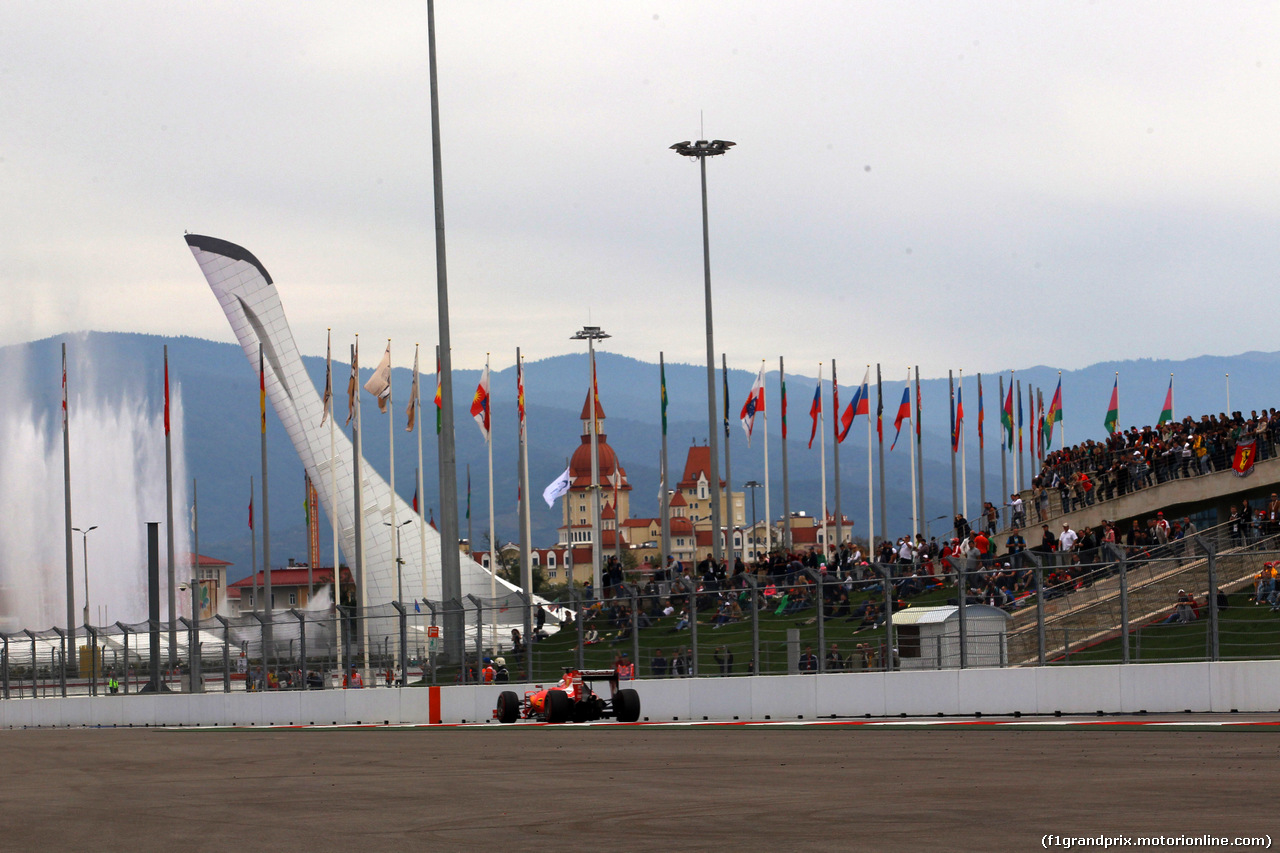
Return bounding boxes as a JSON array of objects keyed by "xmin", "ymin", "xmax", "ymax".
[{"xmin": 0, "ymin": 339, "xmax": 191, "ymax": 631}]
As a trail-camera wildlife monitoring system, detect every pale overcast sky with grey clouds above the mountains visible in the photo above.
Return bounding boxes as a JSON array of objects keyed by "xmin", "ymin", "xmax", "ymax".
[{"xmin": 0, "ymin": 0, "xmax": 1280, "ymax": 375}]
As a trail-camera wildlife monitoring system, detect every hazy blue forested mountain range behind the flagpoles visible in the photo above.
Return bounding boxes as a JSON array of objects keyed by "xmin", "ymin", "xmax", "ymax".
[{"xmin": 12, "ymin": 332, "xmax": 1280, "ymax": 579}]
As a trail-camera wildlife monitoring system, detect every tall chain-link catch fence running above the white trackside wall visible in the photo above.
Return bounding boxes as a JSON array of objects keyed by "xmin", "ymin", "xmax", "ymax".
[{"xmin": 0, "ymin": 517, "xmax": 1280, "ymax": 698}]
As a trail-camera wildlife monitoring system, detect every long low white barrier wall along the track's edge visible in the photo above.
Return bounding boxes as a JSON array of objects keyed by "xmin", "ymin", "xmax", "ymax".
[{"xmin": 0, "ymin": 661, "xmax": 1280, "ymax": 729}]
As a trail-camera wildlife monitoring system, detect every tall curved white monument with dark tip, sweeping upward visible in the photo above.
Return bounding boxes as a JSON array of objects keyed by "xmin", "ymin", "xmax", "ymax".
[{"xmin": 187, "ymin": 234, "xmax": 517, "ymax": 606}]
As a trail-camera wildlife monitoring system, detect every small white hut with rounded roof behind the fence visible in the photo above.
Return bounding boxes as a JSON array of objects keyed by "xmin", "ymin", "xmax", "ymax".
[{"xmin": 893, "ymin": 605, "xmax": 1012, "ymax": 670}]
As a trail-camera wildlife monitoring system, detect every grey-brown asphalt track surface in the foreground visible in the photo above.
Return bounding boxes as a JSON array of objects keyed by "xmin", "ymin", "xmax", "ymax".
[{"xmin": 0, "ymin": 715, "xmax": 1280, "ymax": 853}]
